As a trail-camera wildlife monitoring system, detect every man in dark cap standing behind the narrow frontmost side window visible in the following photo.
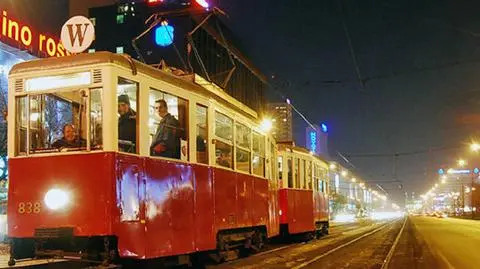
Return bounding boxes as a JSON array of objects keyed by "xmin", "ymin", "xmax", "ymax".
[{"xmin": 118, "ymin": 94, "xmax": 137, "ymax": 153}]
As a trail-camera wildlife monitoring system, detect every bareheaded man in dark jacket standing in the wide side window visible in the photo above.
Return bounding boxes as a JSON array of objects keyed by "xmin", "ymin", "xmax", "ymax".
[{"xmin": 150, "ymin": 99, "xmax": 181, "ymax": 159}]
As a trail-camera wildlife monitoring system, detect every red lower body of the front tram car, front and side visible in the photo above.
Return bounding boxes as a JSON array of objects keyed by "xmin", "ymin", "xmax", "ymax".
[{"xmin": 8, "ymin": 153, "xmax": 278, "ymax": 259}]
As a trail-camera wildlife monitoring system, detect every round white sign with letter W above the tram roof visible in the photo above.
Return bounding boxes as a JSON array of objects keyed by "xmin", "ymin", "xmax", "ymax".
[{"xmin": 60, "ymin": 16, "xmax": 95, "ymax": 53}]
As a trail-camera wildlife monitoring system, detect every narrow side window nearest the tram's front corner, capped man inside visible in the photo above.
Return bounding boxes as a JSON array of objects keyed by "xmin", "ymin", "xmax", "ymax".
[{"xmin": 117, "ymin": 77, "xmax": 138, "ymax": 153}]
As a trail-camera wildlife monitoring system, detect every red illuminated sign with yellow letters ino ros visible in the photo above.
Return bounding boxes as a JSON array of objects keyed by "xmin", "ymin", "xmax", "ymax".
[{"xmin": 0, "ymin": 10, "xmax": 70, "ymax": 57}]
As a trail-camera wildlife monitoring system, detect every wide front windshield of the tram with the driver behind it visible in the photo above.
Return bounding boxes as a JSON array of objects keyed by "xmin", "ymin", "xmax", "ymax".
[{"xmin": 16, "ymin": 89, "xmax": 102, "ymax": 155}]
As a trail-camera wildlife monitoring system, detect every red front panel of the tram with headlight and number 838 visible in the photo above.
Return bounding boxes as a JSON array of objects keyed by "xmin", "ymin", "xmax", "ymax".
[{"xmin": 7, "ymin": 153, "xmax": 115, "ymax": 238}]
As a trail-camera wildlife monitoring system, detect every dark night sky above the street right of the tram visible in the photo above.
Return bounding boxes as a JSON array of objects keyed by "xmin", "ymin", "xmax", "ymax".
[{"xmin": 72, "ymin": 0, "xmax": 480, "ymax": 202}]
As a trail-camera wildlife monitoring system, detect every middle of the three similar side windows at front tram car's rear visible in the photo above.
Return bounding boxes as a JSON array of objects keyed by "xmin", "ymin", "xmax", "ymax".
[{"xmin": 235, "ymin": 123, "xmax": 251, "ymax": 173}]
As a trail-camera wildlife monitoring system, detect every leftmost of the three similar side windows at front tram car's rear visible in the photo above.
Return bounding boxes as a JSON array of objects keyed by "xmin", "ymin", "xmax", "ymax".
[{"xmin": 215, "ymin": 112, "xmax": 233, "ymax": 168}]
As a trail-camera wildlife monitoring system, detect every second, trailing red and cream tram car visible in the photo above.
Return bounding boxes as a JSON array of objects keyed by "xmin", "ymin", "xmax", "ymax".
[{"xmin": 277, "ymin": 144, "xmax": 329, "ymax": 238}]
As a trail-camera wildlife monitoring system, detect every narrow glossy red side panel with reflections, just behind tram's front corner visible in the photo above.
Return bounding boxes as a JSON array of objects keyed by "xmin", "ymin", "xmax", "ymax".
[{"xmin": 117, "ymin": 155, "xmax": 146, "ymax": 258}]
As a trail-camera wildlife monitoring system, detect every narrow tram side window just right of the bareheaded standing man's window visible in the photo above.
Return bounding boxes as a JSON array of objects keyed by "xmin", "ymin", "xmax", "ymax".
[{"xmin": 196, "ymin": 104, "xmax": 208, "ymax": 164}]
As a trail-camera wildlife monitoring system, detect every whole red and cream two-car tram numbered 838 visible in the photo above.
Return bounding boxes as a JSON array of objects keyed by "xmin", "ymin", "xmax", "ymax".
[{"xmin": 4, "ymin": 52, "xmax": 328, "ymax": 264}]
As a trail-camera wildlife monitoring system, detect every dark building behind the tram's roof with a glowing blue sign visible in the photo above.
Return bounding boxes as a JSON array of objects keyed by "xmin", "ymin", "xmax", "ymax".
[{"xmin": 89, "ymin": 0, "xmax": 267, "ymax": 114}]
